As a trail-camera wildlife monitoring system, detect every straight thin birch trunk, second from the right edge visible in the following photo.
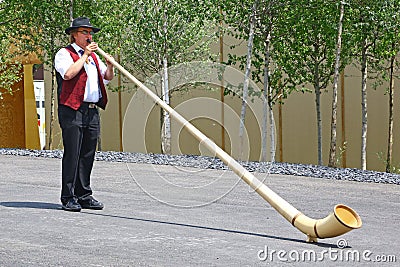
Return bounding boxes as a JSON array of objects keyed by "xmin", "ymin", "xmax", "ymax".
[{"xmin": 361, "ymin": 38, "xmax": 368, "ymax": 170}]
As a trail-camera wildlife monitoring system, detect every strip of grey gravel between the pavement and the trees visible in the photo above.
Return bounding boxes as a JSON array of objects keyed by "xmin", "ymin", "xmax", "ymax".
[{"xmin": 0, "ymin": 148, "xmax": 400, "ymax": 185}]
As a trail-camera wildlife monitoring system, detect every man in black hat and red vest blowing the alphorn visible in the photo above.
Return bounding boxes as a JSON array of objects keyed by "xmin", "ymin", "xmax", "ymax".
[{"xmin": 54, "ymin": 17, "xmax": 114, "ymax": 214}]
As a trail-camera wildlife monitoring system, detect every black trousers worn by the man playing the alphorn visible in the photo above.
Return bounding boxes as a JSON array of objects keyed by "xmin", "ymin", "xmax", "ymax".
[{"xmin": 58, "ymin": 103, "xmax": 100, "ymax": 202}]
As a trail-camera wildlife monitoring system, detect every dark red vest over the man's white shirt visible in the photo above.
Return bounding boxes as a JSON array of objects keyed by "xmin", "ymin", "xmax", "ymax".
[{"xmin": 59, "ymin": 45, "xmax": 108, "ymax": 110}]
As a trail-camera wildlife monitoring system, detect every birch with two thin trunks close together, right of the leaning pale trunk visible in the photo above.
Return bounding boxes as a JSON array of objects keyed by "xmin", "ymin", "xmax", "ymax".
[{"xmin": 252, "ymin": 1, "xmax": 296, "ymax": 162}]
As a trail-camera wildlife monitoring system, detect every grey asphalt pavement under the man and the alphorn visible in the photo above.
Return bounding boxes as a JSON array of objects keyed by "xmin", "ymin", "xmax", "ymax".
[{"xmin": 0, "ymin": 155, "xmax": 400, "ymax": 266}]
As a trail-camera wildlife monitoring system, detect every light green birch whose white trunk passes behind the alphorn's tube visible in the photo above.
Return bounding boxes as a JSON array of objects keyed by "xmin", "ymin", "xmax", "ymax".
[{"xmin": 118, "ymin": 0, "xmax": 218, "ymax": 153}]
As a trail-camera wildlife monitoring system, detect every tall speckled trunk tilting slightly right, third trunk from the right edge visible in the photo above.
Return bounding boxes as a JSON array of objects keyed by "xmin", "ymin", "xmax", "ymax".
[{"xmin": 328, "ymin": 2, "xmax": 344, "ymax": 167}]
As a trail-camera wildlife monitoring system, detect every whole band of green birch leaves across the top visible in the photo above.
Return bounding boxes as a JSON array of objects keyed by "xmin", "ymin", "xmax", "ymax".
[{"xmin": 0, "ymin": 0, "xmax": 400, "ymax": 107}]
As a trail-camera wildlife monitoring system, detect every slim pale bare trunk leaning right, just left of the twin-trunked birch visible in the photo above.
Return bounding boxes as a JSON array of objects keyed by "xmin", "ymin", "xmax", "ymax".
[{"xmin": 239, "ymin": 1, "xmax": 257, "ymax": 159}]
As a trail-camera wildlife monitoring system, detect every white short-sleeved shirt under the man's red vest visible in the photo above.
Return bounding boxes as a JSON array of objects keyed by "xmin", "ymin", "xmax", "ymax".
[{"xmin": 54, "ymin": 43, "xmax": 109, "ymax": 103}]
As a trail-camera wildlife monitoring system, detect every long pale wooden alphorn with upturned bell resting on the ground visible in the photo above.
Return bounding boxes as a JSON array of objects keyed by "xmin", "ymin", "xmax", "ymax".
[{"xmin": 94, "ymin": 41, "xmax": 362, "ymax": 242}]
